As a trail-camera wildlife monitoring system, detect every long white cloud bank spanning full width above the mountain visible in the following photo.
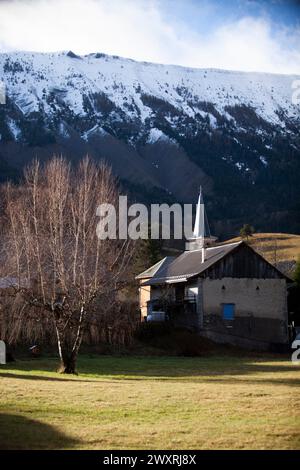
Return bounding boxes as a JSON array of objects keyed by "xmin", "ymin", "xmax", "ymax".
[{"xmin": 0, "ymin": 0, "xmax": 300, "ymax": 74}]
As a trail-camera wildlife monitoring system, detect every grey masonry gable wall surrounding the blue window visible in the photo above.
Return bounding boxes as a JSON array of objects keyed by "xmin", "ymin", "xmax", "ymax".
[{"xmin": 203, "ymin": 278, "xmax": 288, "ymax": 349}]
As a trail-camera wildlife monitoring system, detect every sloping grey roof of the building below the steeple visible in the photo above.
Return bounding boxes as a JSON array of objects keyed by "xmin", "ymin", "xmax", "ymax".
[{"xmin": 140, "ymin": 241, "xmax": 243, "ymax": 285}]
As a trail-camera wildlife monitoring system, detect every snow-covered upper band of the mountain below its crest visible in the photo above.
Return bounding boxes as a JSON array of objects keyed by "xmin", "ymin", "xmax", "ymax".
[{"xmin": 0, "ymin": 52, "xmax": 300, "ymax": 133}]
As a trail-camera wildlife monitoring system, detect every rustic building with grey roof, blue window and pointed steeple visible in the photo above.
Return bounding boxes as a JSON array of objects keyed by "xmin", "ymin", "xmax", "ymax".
[{"xmin": 137, "ymin": 189, "xmax": 291, "ymax": 350}]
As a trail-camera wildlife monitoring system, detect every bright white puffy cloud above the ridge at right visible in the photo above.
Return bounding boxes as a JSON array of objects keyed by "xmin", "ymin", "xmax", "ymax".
[{"xmin": 184, "ymin": 17, "xmax": 300, "ymax": 73}]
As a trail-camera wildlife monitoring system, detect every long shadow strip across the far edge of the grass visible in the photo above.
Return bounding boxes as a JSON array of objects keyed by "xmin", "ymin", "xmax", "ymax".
[{"xmin": 0, "ymin": 356, "xmax": 300, "ymax": 386}]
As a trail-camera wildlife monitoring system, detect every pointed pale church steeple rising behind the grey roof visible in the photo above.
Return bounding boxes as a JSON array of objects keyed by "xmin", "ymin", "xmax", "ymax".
[{"xmin": 187, "ymin": 186, "xmax": 216, "ymax": 251}]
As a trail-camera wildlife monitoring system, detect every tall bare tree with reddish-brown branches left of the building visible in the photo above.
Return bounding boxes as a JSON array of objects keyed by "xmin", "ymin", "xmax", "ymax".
[{"xmin": 4, "ymin": 157, "xmax": 133, "ymax": 373}]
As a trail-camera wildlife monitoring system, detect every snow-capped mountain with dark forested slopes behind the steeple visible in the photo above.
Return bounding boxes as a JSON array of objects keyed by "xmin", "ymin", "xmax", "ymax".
[{"xmin": 0, "ymin": 51, "xmax": 300, "ymax": 232}]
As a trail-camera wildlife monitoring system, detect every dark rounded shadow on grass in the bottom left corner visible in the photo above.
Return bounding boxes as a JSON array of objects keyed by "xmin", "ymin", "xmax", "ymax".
[{"xmin": 0, "ymin": 413, "xmax": 79, "ymax": 450}]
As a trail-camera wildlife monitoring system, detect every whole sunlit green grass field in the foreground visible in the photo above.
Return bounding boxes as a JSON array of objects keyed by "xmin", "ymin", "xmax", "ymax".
[{"xmin": 0, "ymin": 355, "xmax": 300, "ymax": 449}]
